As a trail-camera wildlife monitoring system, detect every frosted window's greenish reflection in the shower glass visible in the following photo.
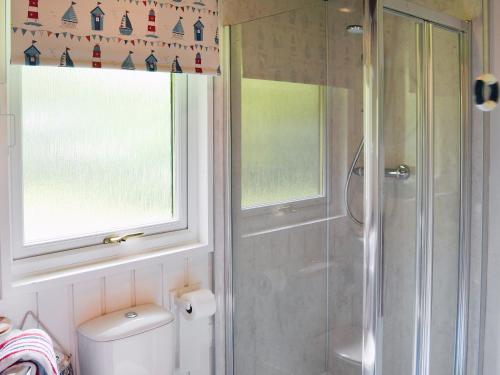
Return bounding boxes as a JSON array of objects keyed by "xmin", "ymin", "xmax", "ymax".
[{"xmin": 241, "ymin": 78, "xmax": 322, "ymax": 207}]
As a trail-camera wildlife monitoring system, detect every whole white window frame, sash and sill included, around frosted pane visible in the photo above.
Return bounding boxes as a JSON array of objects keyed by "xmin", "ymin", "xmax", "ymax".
[{"xmin": 0, "ymin": 0, "xmax": 213, "ymax": 292}]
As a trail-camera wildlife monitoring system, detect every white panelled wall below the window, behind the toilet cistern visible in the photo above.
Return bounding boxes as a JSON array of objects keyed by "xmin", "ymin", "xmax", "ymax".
[{"xmin": 0, "ymin": 254, "xmax": 213, "ymax": 375}]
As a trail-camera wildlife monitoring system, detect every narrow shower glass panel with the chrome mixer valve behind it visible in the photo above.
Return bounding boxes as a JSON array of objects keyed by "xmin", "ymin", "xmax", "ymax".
[{"xmin": 382, "ymin": 12, "xmax": 419, "ymax": 374}]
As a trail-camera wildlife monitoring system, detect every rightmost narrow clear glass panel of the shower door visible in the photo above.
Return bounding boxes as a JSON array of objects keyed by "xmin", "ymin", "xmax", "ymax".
[{"xmin": 430, "ymin": 27, "xmax": 461, "ymax": 375}]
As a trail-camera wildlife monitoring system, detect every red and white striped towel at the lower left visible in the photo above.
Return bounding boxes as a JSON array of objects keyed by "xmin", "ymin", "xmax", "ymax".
[{"xmin": 0, "ymin": 329, "xmax": 57, "ymax": 375}]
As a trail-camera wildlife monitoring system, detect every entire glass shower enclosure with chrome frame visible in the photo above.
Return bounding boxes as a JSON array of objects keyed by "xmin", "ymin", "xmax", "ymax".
[{"xmin": 226, "ymin": 0, "xmax": 471, "ymax": 375}]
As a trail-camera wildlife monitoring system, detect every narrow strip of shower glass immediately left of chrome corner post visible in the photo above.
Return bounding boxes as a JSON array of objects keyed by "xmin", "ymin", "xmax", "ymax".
[{"xmin": 326, "ymin": 0, "xmax": 364, "ymax": 375}]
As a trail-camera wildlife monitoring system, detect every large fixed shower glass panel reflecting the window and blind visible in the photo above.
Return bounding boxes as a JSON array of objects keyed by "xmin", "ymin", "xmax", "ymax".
[{"xmin": 231, "ymin": 0, "xmax": 363, "ymax": 375}]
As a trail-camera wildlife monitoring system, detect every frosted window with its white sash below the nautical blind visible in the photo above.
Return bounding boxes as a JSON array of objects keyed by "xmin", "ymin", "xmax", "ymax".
[{"xmin": 1, "ymin": 66, "xmax": 211, "ymax": 268}]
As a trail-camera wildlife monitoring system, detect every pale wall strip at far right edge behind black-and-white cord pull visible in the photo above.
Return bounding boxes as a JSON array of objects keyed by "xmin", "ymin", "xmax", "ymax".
[{"xmin": 483, "ymin": 0, "xmax": 500, "ymax": 375}]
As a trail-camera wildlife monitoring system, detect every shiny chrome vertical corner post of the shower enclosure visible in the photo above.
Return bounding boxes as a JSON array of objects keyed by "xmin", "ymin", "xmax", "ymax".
[{"xmin": 362, "ymin": 0, "xmax": 384, "ymax": 375}]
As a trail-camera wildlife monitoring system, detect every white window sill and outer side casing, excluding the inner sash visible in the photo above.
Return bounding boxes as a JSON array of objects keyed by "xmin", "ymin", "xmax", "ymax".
[{"xmin": 0, "ymin": 76, "xmax": 214, "ymax": 299}]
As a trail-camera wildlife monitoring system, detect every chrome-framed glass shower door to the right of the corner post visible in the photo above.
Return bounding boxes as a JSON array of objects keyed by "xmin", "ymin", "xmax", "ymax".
[{"xmin": 365, "ymin": 1, "xmax": 469, "ymax": 375}]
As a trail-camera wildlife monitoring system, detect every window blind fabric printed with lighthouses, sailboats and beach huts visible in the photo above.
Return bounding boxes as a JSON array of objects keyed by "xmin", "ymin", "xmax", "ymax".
[{"xmin": 11, "ymin": 0, "xmax": 220, "ymax": 75}]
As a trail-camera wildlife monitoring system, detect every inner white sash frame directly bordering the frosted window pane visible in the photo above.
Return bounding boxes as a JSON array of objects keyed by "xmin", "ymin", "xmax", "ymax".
[{"xmin": 9, "ymin": 66, "xmax": 192, "ymax": 259}]
